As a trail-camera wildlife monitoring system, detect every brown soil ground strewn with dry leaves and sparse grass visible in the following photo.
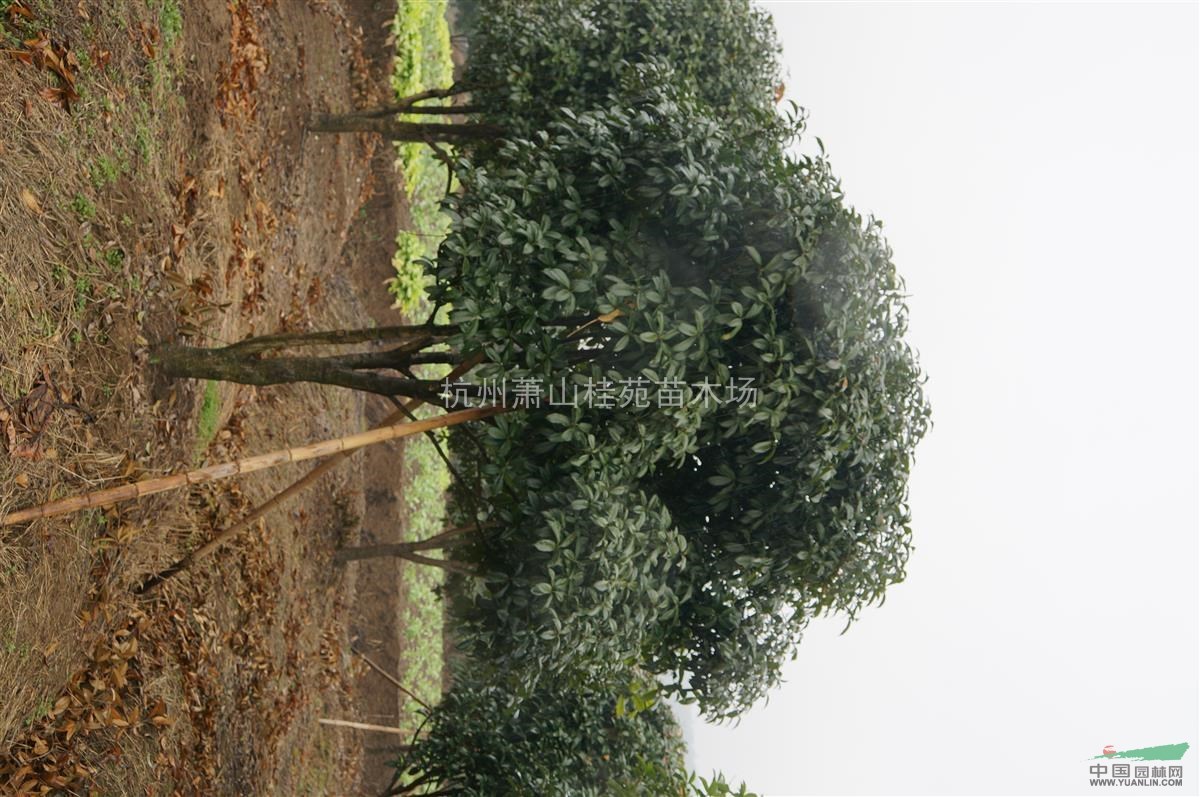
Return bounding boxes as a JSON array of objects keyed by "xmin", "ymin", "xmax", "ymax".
[{"xmin": 0, "ymin": 0, "xmax": 432, "ymax": 795}]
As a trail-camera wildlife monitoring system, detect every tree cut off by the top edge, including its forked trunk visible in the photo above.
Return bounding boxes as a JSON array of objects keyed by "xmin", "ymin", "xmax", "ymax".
[{"xmin": 310, "ymin": 0, "xmax": 780, "ymax": 144}]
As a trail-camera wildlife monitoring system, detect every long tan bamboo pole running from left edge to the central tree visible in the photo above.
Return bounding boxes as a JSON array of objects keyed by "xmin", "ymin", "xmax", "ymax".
[{"xmin": 0, "ymin": 407, "xmax": 503, "ymax": 526}]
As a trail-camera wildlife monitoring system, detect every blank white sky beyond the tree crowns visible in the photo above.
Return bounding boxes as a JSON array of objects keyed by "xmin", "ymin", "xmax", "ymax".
[{"xmin": 692, "ymin": 2, "xmax": 1200, "ymax": 796}]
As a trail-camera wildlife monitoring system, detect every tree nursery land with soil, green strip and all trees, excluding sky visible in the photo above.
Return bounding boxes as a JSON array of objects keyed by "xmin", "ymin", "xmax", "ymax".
[{"xmin": 0, "ymin": 0, "xmax": 930, "ymax": 797}]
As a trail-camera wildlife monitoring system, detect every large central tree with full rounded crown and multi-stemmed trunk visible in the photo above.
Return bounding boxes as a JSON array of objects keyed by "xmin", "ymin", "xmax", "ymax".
[{"xmin": 160, "ymin": 74, "xmax": 928, "ymax": 717}]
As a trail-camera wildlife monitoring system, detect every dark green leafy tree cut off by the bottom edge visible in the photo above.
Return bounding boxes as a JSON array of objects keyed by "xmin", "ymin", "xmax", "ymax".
[{"xmin": 388, "ymin": 667, "xmax": 754, "ymax": 797}]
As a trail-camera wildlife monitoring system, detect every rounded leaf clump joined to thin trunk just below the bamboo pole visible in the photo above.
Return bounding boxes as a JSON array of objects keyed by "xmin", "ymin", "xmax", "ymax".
[{"xmin": 456, "ymin": 458, "xmax": 685, "ymax": 683}]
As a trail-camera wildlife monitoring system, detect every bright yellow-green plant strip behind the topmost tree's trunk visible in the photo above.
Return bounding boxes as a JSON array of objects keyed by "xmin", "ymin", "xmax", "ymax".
[{"xmin": 388, "ymin": 0, "xmax": 454, "ymax": 314}]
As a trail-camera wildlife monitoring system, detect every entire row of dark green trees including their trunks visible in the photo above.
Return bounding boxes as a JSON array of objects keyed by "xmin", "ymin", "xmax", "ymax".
[{"xmin": 156, "ymin": 0, "xmax": 929, "ymax": 795}]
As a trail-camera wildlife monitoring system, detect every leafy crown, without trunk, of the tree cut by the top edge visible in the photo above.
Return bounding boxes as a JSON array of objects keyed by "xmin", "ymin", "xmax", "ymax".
[{"xmin": 466, "ymin": 0, "xmax": 779, "ymax": 136}]
